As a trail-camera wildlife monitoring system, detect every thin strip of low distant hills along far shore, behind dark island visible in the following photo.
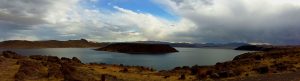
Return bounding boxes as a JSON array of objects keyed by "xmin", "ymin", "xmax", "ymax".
[{"xmin": 0, "ymin": 39, "xmax": 251, "ymax": 49}]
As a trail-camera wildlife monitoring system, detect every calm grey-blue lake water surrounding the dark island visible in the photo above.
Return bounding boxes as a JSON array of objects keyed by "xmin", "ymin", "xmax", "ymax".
[{"xmin": 0, "ymin": 48, "xmax": 248, "ymax": 70}]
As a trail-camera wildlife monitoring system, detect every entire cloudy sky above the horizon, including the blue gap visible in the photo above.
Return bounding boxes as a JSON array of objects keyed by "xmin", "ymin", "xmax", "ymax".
[{"xmin": 0, "ymin": 0, "xmax": 300, "ymax": 44}]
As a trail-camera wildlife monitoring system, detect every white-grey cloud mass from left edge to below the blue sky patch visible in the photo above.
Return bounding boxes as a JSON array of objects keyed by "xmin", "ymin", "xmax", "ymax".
[{"xmin": 0, "ymin": 0, "xmax": 194, "ymax": 41}]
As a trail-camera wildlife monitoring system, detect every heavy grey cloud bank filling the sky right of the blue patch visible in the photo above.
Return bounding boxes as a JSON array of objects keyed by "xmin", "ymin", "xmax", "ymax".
[{"xmin": 157, "ymin": 0, "xmax": 300, "ymax": 44}]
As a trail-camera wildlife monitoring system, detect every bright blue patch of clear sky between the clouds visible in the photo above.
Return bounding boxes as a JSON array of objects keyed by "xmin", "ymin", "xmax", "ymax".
[{"xmin": 85, "ymin": 0, "xmax": 178, "ymax": 21}]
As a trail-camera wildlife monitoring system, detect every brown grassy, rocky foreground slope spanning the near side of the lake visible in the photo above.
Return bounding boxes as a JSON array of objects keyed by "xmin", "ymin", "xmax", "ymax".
[{"xmin": 0, "ymin": 45, "xmax": 300, "ymax": 81}]
